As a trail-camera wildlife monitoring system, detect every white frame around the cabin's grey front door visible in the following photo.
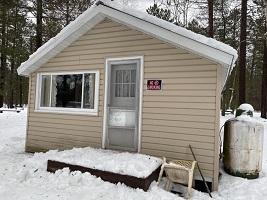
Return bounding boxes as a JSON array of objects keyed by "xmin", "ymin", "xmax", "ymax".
[{"xmin": 102, "ymin": 56, "xmax": 144, "ymax": 153}]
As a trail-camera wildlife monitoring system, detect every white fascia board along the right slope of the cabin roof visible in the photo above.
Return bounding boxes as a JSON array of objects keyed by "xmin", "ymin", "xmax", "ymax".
[{"xmin": 101, "ymin": 6, "xmax": 234, "ymax": 68}]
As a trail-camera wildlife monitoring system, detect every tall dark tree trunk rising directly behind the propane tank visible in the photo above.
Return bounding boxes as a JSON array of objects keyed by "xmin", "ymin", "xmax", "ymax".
[{"xmin": 239, "ymin": 0, "xmax": 247, "ymax": 104}]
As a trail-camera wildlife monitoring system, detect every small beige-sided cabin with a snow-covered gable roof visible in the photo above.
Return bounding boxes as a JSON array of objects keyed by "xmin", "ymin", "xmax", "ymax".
[{"xmin": 18, "ymin": 0, "xmax": 237, "ymax": 190}]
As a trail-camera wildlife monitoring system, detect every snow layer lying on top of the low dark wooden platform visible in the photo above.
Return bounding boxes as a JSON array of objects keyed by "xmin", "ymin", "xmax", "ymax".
[{"xmin": 45, "ymin": 147, "xmax": 162, "ymax": 178}]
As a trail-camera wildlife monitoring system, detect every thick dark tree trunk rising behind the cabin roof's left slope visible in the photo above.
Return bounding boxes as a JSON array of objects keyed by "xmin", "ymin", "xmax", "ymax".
[{"xmin": 36, "ymin": 0, "xmax": 43, "ymax": 49}]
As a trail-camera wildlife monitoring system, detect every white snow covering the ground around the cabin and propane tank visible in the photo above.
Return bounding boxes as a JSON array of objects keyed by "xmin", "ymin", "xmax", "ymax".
[{"xmin": 0, "ymin": 110, "xmax": 267, "ymax": 200}]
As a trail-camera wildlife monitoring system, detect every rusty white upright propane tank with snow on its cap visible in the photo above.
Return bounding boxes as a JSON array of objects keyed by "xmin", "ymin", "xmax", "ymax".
[{"xmin": 223, "ymin": 104, "xmax": 264, "ymax": 179}]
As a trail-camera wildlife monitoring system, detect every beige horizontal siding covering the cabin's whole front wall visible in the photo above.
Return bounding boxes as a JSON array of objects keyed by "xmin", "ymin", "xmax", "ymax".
[{"xmin": 27, "ymin": 20, "xmax": 218, "ymax": 184}]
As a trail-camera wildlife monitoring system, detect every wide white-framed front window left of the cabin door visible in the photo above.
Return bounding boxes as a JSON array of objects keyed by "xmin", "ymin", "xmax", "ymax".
[{"xmin": 37, "ymin": 71, "xmax": 99, "ymax": 113}]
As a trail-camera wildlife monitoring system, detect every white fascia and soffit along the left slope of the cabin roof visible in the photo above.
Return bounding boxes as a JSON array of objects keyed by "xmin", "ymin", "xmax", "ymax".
[{"xmin": 17, "ymin": 7, "xmax": 104, "ymax": 76}]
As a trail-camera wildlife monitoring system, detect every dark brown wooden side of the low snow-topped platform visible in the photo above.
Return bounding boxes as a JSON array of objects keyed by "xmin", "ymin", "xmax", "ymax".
[{"xmin": 47, "ymin": 160, "xmax": 160, "ymax": 191}]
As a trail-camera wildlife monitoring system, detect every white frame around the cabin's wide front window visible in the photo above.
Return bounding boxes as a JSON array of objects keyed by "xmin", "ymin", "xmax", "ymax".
[{"xmin": 35, "ymin": 70, "xmax": 100, "ymax": 115}]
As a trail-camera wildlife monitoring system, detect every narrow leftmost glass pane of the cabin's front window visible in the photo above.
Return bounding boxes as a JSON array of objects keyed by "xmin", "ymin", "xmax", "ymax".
[{"xmin": 40, "ymin": 75, "xmax": 51, "ymax": 107}]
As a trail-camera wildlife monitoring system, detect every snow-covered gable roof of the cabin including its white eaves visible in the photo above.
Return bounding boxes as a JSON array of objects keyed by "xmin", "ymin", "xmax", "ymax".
[{"xmin": 18, "ymin": 0, "xmax": 237, "ymax": 86}]
